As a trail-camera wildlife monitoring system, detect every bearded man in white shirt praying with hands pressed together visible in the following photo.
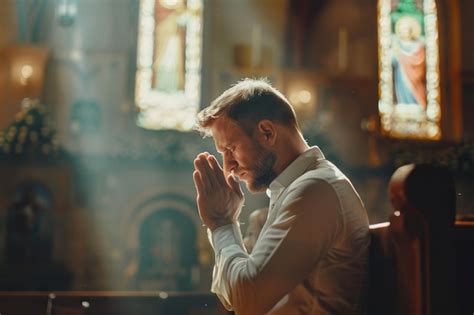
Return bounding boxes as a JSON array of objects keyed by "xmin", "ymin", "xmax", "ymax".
[{"xmin": 193, "ymin": 79, "xmax": 370, "ymax": 315}]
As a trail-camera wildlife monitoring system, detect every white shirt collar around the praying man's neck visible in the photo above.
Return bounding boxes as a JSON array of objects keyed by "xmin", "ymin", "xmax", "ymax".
[{"xmin": 267, "ymin": 146, "xmax": 324, "ymax": 197}]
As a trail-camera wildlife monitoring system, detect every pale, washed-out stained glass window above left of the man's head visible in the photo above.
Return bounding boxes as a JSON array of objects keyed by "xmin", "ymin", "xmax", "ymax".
[{"xmin": 135, "ymin": 0, "xmax": 203, "ymax": 131}]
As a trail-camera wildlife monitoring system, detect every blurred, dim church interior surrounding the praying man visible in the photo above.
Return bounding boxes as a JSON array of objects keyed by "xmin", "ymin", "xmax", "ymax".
[{"xmin": 0, "ymin": 0, "xmax": 474, "ymax": 315}]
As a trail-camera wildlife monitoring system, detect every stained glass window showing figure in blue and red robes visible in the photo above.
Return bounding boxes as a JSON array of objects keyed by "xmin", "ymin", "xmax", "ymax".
[{"xmin": 378, "ymin": 0, "xmax": 441, "ymax": 140}]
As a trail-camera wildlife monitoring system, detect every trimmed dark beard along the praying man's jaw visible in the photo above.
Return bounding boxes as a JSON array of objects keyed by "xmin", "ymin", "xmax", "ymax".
[{"xmin": 247, "ymin": 143, "xmax": 277, "ymax": 192}]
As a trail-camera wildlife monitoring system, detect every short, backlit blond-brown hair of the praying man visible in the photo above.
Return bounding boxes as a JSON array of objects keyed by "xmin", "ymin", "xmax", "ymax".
[{"xmin": 195, "ymin": 78, "xmax": 299, "ymax": 136}]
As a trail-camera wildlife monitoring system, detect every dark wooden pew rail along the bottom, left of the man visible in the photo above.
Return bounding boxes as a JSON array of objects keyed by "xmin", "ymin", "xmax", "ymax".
[{"xmin": 0, "ymin": 291, "xmax": 228, "ymax": 315}]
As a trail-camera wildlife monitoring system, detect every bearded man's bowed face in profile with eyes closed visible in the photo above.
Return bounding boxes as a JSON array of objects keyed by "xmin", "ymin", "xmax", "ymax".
[{"xmin": 212, "ymin": 116, "xmax": 277, "ymax": 192}]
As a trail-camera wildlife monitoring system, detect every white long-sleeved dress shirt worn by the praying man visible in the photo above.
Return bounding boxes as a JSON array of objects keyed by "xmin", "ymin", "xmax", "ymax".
[{"xmin": 209, "ymin": 147, "xmax": 370, "ymax": 315}]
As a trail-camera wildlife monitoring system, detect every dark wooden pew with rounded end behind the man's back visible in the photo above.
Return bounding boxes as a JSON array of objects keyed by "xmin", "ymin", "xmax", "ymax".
[{"xmin": 368, "ymin": 165, "xmax": 474, "ymax": 315}]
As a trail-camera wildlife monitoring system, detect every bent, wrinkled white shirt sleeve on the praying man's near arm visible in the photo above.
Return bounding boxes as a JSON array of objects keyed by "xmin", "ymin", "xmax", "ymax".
[{"xmin": 210, "ymin": 179, "xmax": 341, "ymax": 315}]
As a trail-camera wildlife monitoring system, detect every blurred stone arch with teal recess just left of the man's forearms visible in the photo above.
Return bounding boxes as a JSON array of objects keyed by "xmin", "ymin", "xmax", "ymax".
[{"xmin": 121, "ymin": 193, "xmax": 208, "ymax": 291}]
